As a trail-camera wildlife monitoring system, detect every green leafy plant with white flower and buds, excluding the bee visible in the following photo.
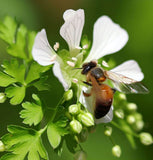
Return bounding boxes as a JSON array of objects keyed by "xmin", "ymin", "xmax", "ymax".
[{"xmin": 0, "ymin": 9, "xmax": 153, "ymax": 160}]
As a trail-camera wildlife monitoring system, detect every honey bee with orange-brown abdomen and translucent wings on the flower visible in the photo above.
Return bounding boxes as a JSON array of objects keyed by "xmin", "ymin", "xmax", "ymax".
[{"xmin": 81, "ymin": 61, "xmax": 148, "ymax": 119}]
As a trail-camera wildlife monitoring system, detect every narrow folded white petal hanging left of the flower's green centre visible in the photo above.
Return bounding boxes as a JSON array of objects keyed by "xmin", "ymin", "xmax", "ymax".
[{"xmin": 53, "ymin": 61, "xmax": 69, "ymax": 91}]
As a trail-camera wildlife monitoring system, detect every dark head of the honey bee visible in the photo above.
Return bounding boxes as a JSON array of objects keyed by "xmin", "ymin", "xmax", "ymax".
[{"xmin": 81, "ymin": 61, "xmax": 97, "ymax": 74}]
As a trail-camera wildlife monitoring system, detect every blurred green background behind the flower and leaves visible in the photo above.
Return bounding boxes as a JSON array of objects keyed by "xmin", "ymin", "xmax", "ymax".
[{"xmin": 0, "ymin": 0, "xmax": 153, "ymax": 160}]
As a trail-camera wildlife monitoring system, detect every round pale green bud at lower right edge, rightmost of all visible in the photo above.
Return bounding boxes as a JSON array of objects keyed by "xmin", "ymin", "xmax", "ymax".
[{"xmin": 140, "ymin": 132, "xmax": 153, "ymax": 145}]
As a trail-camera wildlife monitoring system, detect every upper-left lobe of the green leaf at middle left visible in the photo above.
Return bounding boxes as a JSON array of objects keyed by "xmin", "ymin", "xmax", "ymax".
[{"xmin": 2, "ymin": 59, "xmax": 25, "ymax": 84}]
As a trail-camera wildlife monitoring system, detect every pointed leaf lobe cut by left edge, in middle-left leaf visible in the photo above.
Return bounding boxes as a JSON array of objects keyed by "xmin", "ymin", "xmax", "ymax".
[{"xmin": 0, "ymin": 72, "xmax": 16, "ymax": 87}]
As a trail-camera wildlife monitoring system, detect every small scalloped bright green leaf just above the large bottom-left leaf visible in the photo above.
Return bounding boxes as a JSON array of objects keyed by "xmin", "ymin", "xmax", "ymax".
[{"xmin": 20, "ymin": 94, "xmax": 43, "ymax": 126}]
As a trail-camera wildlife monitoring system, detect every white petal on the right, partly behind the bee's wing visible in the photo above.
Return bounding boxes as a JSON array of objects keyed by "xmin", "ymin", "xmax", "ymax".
[{"xmin": 111, "ymin": 60, "xmax": 144, "ymax": 81}]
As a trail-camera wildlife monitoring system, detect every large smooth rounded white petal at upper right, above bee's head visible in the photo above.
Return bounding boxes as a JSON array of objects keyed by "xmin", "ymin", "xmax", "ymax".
[{"xmin": 86, "ymin": 16, "xmax": 128, "ymax": 61}]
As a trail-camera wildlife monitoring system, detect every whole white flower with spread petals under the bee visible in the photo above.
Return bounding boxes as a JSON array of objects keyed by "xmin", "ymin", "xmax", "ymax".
[{"xmin": 32, "ymin": 9, "xmax": 143, "ymax": 123}]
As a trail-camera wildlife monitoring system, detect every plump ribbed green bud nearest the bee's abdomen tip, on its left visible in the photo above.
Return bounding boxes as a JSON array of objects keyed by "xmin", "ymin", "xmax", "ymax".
[{"xmin": 78, "ymin": 112, "xmax": 94, "ymax": 127}]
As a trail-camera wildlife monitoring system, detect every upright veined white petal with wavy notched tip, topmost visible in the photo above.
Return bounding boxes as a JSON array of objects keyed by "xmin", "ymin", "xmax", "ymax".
[{"xmin": 60, "ymin": 9, "xmax": 84, "ymax": 50}]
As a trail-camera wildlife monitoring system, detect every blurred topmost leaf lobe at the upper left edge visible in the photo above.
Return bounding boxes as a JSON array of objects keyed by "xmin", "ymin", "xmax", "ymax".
[{"xmin": 0, "ymin": 16, "xmax": 17, "ymax": 44}]
